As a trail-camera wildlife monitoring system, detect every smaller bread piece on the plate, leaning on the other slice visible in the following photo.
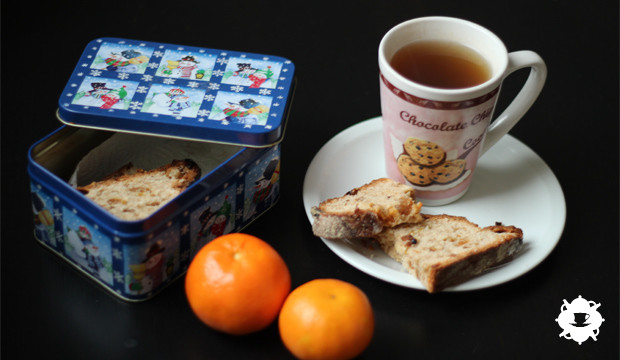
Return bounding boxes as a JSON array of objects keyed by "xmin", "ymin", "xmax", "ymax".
[{"xmin": 311, "ymin": 178, "xmax": 423, "ymax": 239}]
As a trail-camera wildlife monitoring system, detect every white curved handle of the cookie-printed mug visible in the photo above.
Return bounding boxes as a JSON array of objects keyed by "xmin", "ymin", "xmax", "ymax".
[{"xmin": 480, "ymin": 50, "xmax": 547, "ymax": 156}]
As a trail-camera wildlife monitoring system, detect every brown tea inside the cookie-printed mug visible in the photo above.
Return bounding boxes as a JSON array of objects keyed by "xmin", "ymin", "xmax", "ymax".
[{"xmin": 390, "ymin": 40, "xmax": 491, "ymax": 89}]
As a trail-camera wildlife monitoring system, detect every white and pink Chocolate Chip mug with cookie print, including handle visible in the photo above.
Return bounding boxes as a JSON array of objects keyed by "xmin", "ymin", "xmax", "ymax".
[{"xmin": 379, "ymin": 17, "xmax": 547, "ymax": 206}]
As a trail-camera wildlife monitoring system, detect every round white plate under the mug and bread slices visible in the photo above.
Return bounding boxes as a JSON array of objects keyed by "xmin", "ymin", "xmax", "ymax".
[{"xmin": 303, "ymin": 117, "xmax": 566, "ymax": 291}]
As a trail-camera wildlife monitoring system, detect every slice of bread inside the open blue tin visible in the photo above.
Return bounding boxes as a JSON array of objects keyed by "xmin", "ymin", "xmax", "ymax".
[{"xmin": 78, "ymin": 160, "xmax": 201, "ymax": 220}]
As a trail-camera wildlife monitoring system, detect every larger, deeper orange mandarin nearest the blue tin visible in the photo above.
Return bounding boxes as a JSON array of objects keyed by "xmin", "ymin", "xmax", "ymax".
[{"xmin": 185, "ymin": 233, "xmax": 291, "ymax": 335}]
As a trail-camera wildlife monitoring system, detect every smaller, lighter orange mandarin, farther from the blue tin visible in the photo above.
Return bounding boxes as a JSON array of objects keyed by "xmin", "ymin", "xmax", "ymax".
[{"xmin": 278, "ymin": 279, "xmax": 375, "ymax": 359}]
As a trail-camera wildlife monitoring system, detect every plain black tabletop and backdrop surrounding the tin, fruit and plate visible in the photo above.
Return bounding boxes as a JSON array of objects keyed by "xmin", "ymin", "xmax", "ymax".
[{"xmin": 2, "ymin": 0, "xmax": 619, "ymax": 359}]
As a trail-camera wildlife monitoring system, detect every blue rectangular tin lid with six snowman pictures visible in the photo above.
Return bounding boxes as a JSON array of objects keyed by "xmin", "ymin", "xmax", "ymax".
[{"xmin": 58, "ymin": 38, "xmax": 295, "ymax": 147}]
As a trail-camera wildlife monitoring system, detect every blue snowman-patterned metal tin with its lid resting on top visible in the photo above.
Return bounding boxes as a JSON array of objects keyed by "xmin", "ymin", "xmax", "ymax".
[{"xmin": 28, "ymin": 38, "xmax": 294, "ymax": 301}]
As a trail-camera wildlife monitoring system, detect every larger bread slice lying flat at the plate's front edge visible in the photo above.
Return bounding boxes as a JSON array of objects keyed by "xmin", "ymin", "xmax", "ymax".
[{"xmin": 374, "ymin": 215, "xmax": 523, "ymax": 293}]
